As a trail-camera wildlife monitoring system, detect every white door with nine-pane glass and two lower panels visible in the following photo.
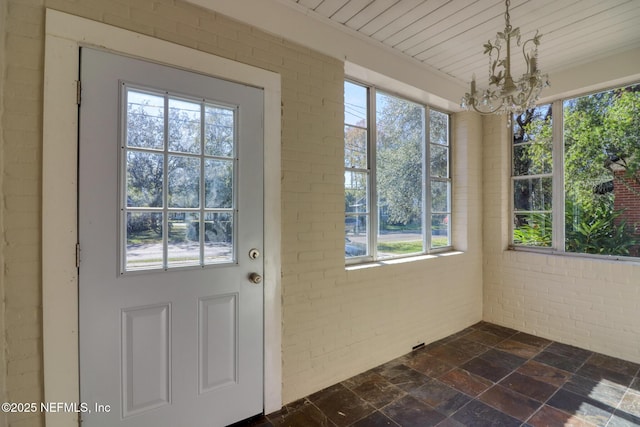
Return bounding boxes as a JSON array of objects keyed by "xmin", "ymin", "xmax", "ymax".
[{"xmin": 79, "ymin": 48, "xmax": 263, "ymax": 427}]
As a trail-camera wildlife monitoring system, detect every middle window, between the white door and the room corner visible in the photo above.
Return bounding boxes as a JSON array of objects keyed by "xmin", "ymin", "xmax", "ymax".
[{"xmin": 344, "ymin": 81, "xmax": 451, "ymax": 262}]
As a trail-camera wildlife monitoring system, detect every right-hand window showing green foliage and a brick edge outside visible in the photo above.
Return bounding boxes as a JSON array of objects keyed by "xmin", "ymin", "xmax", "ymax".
[{"xmin": 512, "ymin": 85, "xmax": 640, "ymax": 257}]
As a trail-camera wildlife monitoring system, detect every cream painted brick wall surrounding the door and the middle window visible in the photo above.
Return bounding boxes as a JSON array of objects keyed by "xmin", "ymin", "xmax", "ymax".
[{"xmin": 0, "ymin": 0, "xmax": 482, "ymax": 427}]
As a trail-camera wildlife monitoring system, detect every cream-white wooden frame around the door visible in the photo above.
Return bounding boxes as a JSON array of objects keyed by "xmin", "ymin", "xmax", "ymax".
[{"xmin": 42, "ymin": 9, "xmax": 282, "ymax": 427}]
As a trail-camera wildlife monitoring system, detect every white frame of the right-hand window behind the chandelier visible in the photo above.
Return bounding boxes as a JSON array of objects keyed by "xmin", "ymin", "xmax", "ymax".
[{"xmin": 507, "ymin": 80, "xmax": 640, "ymax": 262}]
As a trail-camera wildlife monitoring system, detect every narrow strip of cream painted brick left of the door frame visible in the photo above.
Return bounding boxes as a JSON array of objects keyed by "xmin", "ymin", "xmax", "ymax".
[{"xmin": 0, "ymin": 1, "xmax": 44, "ymax": 427}]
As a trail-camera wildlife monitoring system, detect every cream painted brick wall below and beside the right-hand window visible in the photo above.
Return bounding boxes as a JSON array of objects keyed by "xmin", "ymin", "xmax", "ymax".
[{"xmin": 483, "ymin": 117, "xmax": 640, "ymax": 362}]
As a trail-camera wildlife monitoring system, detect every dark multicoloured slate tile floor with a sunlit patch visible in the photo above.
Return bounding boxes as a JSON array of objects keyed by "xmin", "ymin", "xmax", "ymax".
[{"xmin": 234, "ymin": 322, "xmax": 640, "ymax": 427}]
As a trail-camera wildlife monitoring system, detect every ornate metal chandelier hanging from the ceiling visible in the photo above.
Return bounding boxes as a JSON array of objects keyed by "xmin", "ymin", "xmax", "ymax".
[{"xmin": 460, "ymin": 0, "xmax": 549, "ymax": 114}]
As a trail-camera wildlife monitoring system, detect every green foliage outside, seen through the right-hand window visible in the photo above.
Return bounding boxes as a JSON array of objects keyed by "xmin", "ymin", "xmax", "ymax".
[{"xmin": 514, "ymin": 85, "xmax": 640, "ymax": 255}]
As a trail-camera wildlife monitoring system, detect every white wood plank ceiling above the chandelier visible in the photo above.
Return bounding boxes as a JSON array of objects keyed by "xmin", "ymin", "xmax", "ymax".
[{"xmin": 282, "ymin": 0, "xmax": 640, "ymax": 86}]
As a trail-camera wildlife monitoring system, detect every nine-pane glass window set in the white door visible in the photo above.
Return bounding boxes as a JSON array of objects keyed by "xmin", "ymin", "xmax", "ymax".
[{"xmin": 121, "ymin": 84, "xmax": 237, "ymax": 273}]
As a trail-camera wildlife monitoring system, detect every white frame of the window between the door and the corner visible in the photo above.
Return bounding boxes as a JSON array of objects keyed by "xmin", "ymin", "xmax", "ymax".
[{"xmin": 343, "ymin": 76, "xmax": 454, "ymax": 266}]
